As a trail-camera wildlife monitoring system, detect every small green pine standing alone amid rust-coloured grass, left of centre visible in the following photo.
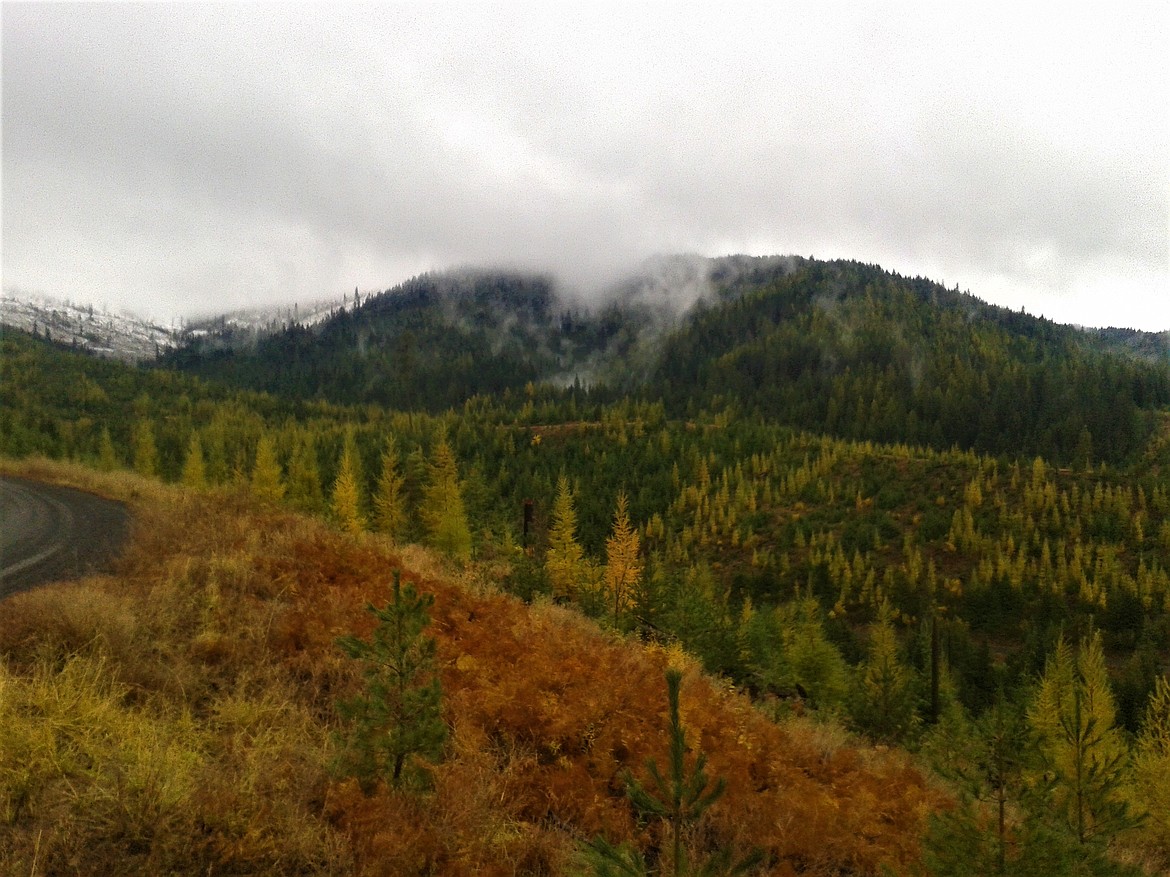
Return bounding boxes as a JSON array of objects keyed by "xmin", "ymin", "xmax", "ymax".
[{"xmin": 337, "ymin": 569, "xmax": 447, "ymax": 792}]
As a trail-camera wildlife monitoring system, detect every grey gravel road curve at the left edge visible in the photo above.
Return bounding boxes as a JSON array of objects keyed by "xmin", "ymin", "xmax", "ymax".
[{"xmin": 0, "ymin": 477, "xmax": 130, "ymax": 600}]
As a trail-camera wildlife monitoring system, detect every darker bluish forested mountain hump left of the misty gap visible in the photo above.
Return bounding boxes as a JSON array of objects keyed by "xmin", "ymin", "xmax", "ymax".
[{"xmin": 164, "ymin": 272, "xmax": 664, "ymax": 410}]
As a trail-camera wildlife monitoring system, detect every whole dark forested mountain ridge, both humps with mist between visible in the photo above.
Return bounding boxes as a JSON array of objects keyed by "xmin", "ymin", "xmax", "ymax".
[{"xmin": 164, "ymin": 256, "xmax": 1170, "ymax": 463}]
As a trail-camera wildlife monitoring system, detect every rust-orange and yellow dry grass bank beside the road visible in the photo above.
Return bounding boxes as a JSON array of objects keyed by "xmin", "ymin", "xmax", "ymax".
[{"xmin": 0, "ymin": 462, "xmax": 937, "ymax": 875}]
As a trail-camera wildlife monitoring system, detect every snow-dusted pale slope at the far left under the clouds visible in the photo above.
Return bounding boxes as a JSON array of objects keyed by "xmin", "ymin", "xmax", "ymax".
[{"xmin": 0, "ymin": 292, "xmax": 179, "ymax": 362}]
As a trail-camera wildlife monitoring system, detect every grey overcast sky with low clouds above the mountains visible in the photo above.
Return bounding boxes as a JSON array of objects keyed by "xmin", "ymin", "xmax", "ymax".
[{"xmin": 0, "ymin": 0, "xmax": 1170, "ymax": 331}]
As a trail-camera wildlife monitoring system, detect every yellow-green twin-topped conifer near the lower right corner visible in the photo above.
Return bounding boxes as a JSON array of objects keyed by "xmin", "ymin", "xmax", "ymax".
[{"xmin": 1027, "ymin": 633, "xmax": 1135, "ymax": 845}]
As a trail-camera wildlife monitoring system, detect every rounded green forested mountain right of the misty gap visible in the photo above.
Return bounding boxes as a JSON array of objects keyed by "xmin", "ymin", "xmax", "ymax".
[{"xmin": 647, "ymin": 262, "xmax": 1170, "ymax": 462}]
